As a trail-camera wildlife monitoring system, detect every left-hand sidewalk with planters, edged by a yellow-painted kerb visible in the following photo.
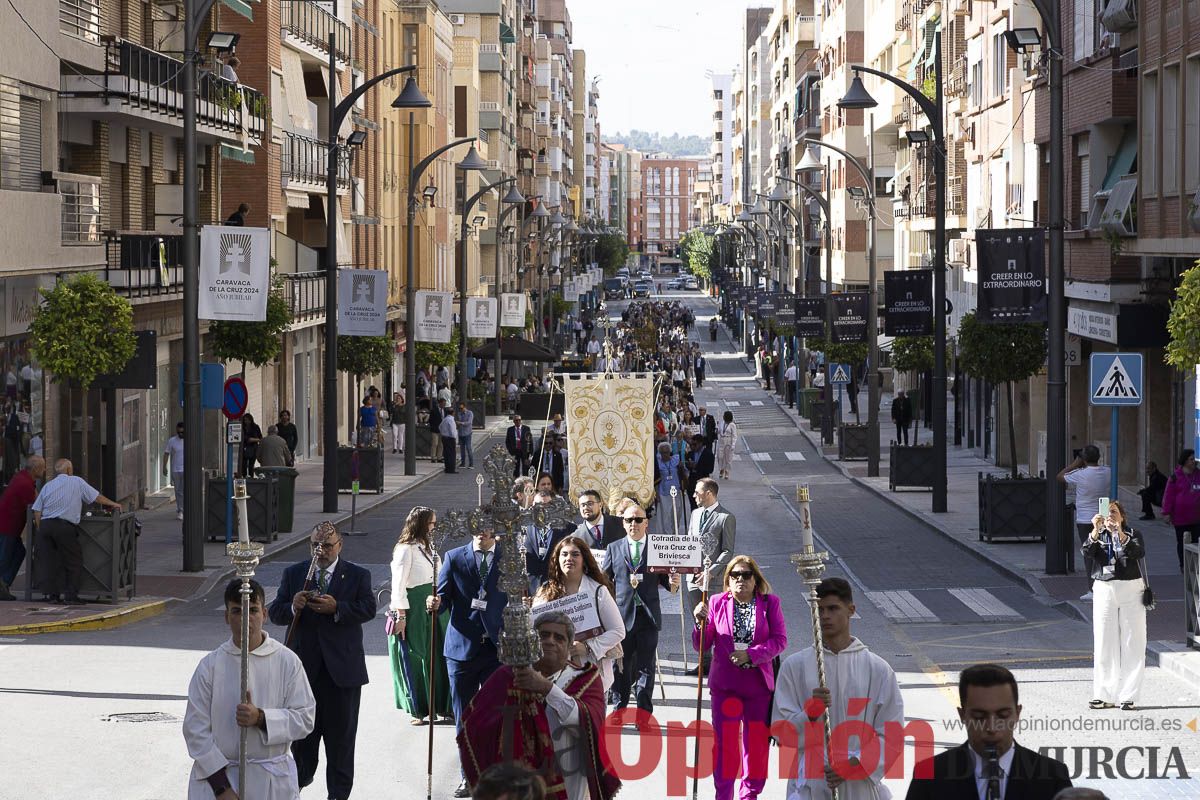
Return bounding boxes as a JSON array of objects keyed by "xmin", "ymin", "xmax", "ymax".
[{"xmin": 0, "ymin": 416, "xmax": 509, "ymax": 636}]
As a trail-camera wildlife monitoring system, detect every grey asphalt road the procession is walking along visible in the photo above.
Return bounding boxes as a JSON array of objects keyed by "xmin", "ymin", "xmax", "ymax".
[{"xmin": 0, "ymin": 291, "xmax": 1200, "ymax": 800}]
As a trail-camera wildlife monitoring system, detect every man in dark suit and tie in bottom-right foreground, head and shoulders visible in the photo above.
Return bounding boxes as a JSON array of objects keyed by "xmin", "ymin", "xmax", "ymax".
[{"xmin": 907, "ymin": 664, "xmax": 1070, "ymax": 800}]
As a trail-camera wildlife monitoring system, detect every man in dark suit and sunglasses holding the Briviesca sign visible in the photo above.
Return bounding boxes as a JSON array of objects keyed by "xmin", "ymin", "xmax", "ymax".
[{"xmin": 600, "ymin": 504, "xmax": 679, "ymax": 714}]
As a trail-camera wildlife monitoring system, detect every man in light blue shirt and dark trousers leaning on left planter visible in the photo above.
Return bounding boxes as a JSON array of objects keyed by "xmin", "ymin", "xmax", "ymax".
[{"xmin": 32, "ymin": 458, "xmax": 121, "ymax": 606}]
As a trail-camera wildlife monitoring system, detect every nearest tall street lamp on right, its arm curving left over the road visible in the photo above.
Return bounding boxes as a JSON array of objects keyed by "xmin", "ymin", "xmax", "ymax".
[{"xmin": 838, "ymin": 32, "xmax": 950, "ymax": 513}]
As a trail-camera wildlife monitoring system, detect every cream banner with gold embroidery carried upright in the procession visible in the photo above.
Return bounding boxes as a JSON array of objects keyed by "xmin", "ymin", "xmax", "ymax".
[{"xmin": 563, "ymin": 374, "xmax": 654, "ymax": 510}]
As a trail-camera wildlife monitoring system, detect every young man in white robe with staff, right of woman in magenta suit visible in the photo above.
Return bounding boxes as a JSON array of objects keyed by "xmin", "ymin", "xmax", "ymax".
[{"xmin": 772, "ymin": 578, "xmax": 904, "ymax": 800}]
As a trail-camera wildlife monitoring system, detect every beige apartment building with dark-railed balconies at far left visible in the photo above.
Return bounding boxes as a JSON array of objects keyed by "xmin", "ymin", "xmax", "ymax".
[{"xmin": 0, "ymin": 0, "xmax": 268, "ymax": 500}]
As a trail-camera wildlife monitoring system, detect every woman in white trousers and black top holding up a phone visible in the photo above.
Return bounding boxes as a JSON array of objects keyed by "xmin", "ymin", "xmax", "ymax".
[{"xmin": 1082, "ymin": 500, "xmax": 1146, "ymax": 711}]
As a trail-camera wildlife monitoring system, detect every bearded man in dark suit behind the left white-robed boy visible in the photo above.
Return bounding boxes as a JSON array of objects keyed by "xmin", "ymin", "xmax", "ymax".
[{"xmin": 269, "ymin": 522, "xmax": 376, "ymax": 800}]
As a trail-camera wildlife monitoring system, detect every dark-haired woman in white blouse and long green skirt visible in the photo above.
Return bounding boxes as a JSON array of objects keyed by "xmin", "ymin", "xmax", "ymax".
[{"xmin": 388, "ymin": 506, "xmax": 450, "ymax": 726}]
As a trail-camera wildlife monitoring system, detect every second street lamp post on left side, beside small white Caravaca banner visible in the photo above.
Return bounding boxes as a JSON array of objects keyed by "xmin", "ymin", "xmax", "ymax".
[{"xmin": 392, "ymin": 101, "xmax": 487, "ymax": 475}]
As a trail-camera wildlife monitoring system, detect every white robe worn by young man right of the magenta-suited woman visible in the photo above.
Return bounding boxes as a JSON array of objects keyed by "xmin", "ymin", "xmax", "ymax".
[{"xmin": 772, "ymin": 639, "xmax": 904, "ymax": 800}]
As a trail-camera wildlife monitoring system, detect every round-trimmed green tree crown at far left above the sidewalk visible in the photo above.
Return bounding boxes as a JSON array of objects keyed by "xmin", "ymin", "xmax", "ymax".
[{"xmin": 29, "ymin": 273, "xmax": 137, "ymax": 391}]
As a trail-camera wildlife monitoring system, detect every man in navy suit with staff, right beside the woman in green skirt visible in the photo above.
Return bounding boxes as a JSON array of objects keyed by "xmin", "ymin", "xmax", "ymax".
[{"xmin": 426, "ymin": 527, "xmax": 506, "ymax": 798}]
